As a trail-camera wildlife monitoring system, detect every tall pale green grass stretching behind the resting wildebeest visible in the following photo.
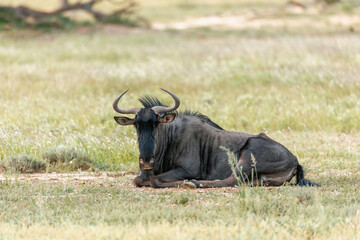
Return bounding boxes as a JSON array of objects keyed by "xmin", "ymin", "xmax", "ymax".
[{"xmin": 0, "ymin": 32, "xmax": 360, "ymax": 170}]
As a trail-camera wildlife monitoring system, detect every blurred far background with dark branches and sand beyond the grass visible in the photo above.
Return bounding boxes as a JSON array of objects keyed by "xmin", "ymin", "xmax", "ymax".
[{"xmin": 0, "ymin": 0, "xmax": 360, "ymax": 32}]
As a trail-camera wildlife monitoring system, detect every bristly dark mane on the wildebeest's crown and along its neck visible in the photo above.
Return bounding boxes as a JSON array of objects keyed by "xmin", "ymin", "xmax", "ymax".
[{"xmin": 138, "ymin": 95, "xmax": 223, "ymax": 130}]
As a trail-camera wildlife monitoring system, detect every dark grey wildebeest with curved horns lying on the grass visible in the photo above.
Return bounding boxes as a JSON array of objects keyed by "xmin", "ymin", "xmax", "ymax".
[{"xmin": 113, "ymin": 89, "xmax": 314, "ymax": 188}]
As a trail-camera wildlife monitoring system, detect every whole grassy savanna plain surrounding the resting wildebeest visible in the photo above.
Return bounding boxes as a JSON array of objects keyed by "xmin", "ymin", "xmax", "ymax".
[{"xmin": 0, "ymin": 1, "xmax": 360, "ymax": 239}]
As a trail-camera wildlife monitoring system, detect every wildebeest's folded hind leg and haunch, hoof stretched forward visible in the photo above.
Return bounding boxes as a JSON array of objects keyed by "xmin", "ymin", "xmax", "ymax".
[{"xmin": 186, "ymin": 137, "xmax": 298, "ymax": 188}]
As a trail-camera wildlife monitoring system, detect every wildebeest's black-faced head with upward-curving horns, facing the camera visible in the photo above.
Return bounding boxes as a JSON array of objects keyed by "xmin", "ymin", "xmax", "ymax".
[{"xmin": 113, "ymin": 88, "xmax": 180, "ymax": 171}]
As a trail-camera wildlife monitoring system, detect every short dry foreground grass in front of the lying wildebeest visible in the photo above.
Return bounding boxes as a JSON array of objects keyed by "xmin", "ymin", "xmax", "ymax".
[{"xmin": 0, "ymin": 176, "xmax": 360, "ymax": 239}]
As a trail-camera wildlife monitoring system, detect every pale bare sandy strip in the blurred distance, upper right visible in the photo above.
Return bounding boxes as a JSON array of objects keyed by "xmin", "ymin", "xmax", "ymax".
[{"xmin": 86, "ymin": 12, "xmax": 360, "ymax": 34}]
